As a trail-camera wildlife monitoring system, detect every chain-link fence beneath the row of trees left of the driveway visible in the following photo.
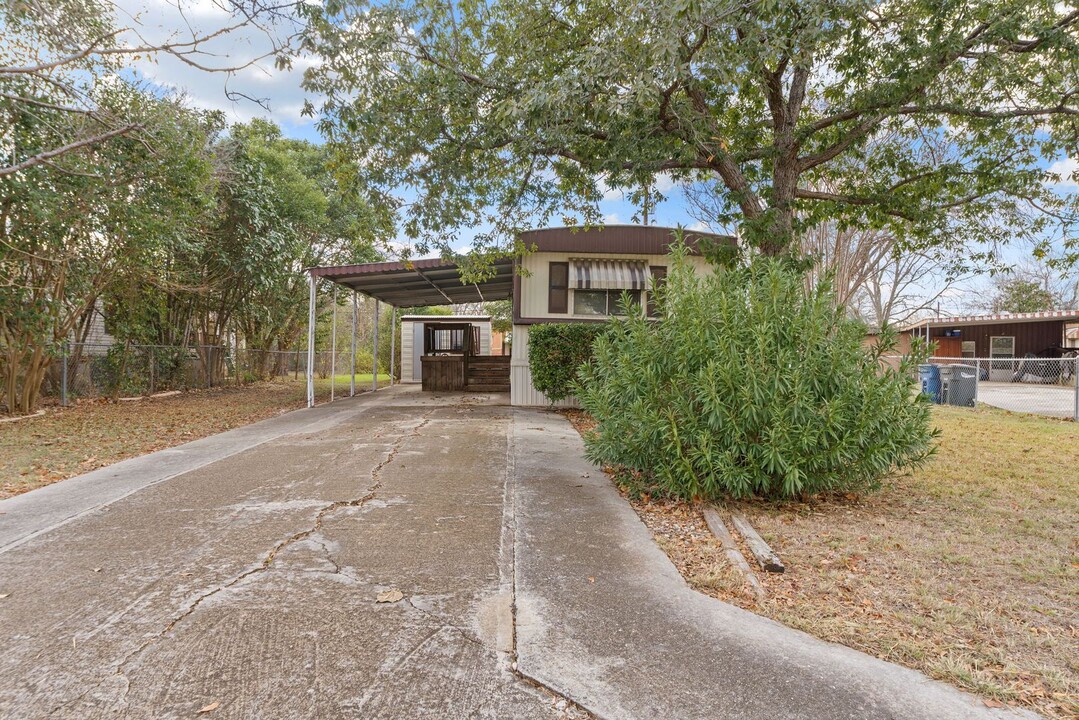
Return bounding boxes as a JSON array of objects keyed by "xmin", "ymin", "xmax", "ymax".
[{"xmin": 35, "ymin": 343, "xmax": 388, "ymax": 405}]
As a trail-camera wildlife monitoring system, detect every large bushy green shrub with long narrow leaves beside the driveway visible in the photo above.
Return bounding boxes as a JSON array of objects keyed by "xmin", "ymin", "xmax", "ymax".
[{"xmin": 574, "ymin": 248, "xmax": 934, "ymax": 500}]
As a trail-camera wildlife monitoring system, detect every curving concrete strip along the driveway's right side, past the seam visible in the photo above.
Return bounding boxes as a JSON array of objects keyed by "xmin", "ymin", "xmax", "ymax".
[{"xmin": 514, "ymin": 409, "xmax": 1038, "ymax": 720}]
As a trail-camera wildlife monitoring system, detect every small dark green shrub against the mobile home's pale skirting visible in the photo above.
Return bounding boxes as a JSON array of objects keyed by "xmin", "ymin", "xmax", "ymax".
[{"xmin": 529, "ymin": 323, "xmax": 607, "ymax": 402}]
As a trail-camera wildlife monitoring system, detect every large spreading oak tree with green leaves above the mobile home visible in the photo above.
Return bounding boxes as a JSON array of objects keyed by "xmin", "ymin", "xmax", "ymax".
[{"xmin": 304, "ymin": 0, "xmax": 1079, "ymax": 255}]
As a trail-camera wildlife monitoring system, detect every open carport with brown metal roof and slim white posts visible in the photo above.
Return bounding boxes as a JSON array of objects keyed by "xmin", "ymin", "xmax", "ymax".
[{"xmin": 306, "ymin": 257, "xmax": 514, "ymax": 407}]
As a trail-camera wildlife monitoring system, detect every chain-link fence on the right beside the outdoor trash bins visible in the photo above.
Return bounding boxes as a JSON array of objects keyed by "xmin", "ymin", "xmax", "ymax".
[{"xmin": 902, "ymin": 353, "xmax": 1079, "ymax": 420}]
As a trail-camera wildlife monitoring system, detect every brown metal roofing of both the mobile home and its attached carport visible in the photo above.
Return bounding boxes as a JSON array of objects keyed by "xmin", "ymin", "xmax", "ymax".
[{"xmin": 310, "ymin": 226, "xmax": 735, "ymax": 308}]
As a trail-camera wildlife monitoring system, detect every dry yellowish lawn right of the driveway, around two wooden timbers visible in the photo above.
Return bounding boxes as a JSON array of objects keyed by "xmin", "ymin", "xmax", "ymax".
[{"xmin": 565, "ymin": 407, "xmax": 1079, "ymax": 718}]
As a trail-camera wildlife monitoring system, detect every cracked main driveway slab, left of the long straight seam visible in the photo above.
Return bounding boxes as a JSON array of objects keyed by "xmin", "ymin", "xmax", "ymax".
[{"xmin": 0, "ymin": 390, "xmax": 564, "ymax": 719}]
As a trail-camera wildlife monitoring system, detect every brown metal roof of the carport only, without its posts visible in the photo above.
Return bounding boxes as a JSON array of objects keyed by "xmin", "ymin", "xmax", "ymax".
[{"xmin": 310, "ymin": 258, "xmax": 514, "ymax": 308}]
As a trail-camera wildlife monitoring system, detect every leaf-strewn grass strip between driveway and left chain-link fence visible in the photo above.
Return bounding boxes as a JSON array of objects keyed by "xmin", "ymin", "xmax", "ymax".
[{"xmin": 0, "ymin": 375, "xmax": 384, "ymax": 499}]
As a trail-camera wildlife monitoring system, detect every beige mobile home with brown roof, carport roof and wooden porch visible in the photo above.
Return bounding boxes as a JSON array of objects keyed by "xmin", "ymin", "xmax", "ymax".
[{"xmin": 310, "ymin": 226, "xmax": 735, "ymax": 406}]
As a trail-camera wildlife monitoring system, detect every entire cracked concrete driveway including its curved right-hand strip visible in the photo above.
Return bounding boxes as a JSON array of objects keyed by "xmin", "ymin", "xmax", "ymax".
[{"xmin": 0, "ymin": 389, "xmax": 1035, "ymax": 720}]
